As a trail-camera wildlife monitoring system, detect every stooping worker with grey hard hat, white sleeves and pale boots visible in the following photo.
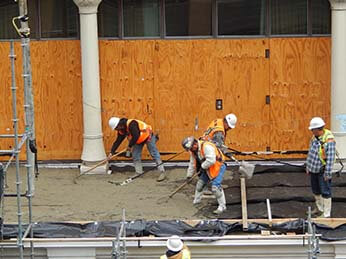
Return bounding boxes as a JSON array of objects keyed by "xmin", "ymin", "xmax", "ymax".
[{"xmin": 182, "ymin": 136, "xmax": 226, "ymax": 215}]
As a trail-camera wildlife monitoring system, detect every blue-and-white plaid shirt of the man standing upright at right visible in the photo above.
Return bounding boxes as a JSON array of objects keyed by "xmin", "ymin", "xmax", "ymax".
[{"xmin": 306, "ymin": 134, "xmax": 336, "ymax": 178}]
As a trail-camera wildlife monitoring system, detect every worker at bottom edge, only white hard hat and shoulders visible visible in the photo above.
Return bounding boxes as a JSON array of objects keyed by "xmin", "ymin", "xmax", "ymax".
[{"xmin": 160, "ymin": 236, "xmax": 191, "ymax": 259}]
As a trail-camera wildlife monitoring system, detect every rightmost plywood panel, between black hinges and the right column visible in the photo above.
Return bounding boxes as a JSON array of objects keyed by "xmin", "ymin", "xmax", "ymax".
[{"xmin": 270, "ymin": 38, "xmax": 331, "ymax": 150}]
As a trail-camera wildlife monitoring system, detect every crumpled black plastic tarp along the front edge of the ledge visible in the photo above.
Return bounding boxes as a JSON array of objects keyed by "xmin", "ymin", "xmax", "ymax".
[{"xmin": 3, "ymin": 219, "xmax": 346, "ymax": 241}]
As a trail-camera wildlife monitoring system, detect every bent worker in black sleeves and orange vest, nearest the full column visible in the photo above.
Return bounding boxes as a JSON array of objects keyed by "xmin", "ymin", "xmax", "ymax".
[{"xmin": 108, "ymin": 117, "xmax": 166, "ymax": 182}]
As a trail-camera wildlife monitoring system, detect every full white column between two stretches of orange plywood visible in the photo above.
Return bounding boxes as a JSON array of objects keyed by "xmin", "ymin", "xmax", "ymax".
[{"xmin": 73, "ymin": 0, "xmax": 107, "ymax": 173}]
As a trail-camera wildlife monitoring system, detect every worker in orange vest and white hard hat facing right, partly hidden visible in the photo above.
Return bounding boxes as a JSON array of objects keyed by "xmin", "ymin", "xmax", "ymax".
[{"xmin": 201, "ymin": 113, "xmax": 237, "ymax": 152}]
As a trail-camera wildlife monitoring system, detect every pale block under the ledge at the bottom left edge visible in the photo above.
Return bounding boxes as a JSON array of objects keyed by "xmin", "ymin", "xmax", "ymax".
[{"xmin": 47, "ymin": 246, "xmax": 96, "ymax": 259}]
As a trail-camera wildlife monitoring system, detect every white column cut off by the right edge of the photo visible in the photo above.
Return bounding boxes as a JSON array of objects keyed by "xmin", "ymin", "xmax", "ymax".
[{"xmin": 329, "ymin": 0, "xmax": 346, "ymax": 159}]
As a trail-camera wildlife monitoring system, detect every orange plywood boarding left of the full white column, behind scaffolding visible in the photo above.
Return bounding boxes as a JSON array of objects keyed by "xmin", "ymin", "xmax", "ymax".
[{"xmin": 0, "ymin": 41, "xmax": 83, "ymax": 160}]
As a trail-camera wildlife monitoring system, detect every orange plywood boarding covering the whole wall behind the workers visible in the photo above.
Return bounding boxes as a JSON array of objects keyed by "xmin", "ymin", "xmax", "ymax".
[{"xmin": 0, "ymin": 37, "xmax": 331, "ymax": 160}]
